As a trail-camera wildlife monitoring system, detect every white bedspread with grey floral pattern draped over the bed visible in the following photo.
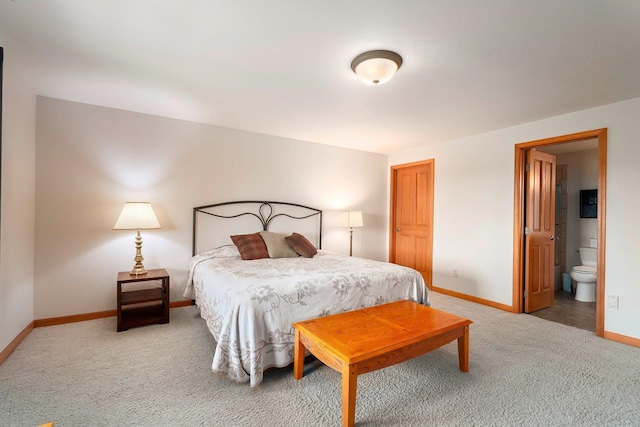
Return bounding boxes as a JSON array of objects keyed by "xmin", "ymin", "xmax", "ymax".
[{"xmin": 185, "ymin": 247, "xmax": 429, "ymax": 387}]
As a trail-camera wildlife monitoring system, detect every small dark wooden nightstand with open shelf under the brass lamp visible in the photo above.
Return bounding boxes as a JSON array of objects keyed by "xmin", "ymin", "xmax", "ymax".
[{"xmin": 117, "ymin": 268, "xmax": 169, "ymax": 332}]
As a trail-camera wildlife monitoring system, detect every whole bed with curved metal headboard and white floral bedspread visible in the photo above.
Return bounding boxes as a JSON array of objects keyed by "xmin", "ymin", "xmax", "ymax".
[{"xmin": 184, "ymin": 201, "xmax": 429, "ymax": 387}]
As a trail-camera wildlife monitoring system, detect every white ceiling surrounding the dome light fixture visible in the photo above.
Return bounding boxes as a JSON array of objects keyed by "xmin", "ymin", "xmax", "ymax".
[{"xmin": 0, "ymin": 0, "xmax": 640, "ymax": 153}]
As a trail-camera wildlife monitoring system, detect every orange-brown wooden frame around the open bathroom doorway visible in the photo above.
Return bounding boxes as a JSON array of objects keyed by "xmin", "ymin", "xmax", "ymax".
[{"xmin": 512, "ymin": 128, "xmax": 607, "ymax": 337}]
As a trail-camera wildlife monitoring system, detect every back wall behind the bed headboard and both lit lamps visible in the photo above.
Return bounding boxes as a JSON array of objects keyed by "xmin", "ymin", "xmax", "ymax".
[{"xmin": 35, "ymin": 97, "xmax": 388, "ymax": 319}]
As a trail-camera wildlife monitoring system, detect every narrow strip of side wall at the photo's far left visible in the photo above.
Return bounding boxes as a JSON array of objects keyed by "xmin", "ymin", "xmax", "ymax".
[{"xmin": 0, "ymin": 46, "xmax": 36, "ymax": 351}]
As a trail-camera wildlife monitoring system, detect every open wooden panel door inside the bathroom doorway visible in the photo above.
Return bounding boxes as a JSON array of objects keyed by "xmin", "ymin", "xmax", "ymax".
[{"xmin": 524, "ymin": 150, "xmax": 556, "ymax": 313}]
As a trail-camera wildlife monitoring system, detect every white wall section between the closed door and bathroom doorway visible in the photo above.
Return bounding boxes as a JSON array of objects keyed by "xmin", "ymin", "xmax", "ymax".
[{"xmin": 389, "ymin": 134, "xmax": 513, "ymax": 305}]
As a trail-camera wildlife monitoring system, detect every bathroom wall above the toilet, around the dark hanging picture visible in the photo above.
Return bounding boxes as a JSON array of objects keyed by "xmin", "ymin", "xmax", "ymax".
[{"xmin": 556, "ymin": 150, "xmax": 599, "ymax": 273}]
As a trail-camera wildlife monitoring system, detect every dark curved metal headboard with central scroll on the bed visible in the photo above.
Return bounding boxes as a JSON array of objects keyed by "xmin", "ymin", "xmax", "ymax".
[{"xmin": 191, "ymin": 200, "xmax": 322, "ymax": 255}]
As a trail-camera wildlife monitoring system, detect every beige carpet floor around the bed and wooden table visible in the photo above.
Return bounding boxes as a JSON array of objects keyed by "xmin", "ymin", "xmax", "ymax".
[{"xmin": 0, "ymin": 293, "xmax": 640, "ymax": 427}]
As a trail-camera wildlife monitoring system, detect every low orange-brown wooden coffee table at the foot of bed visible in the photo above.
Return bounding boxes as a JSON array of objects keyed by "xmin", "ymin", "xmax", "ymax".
[{"xmin": 293, "ymin": 301, "xmax": 472, "ymax": 426}]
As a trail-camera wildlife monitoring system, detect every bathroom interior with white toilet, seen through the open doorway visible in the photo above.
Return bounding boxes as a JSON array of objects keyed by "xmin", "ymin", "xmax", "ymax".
[{"xmin": 531, "ymin": 139, "xmax": 598, "ymax": 332}]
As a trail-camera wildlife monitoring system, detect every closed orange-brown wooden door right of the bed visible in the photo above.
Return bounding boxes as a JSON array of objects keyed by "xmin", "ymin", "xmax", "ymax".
[{"xmin": 389, "ymin": 160, "xmax": 434, "ymax": 289}]
